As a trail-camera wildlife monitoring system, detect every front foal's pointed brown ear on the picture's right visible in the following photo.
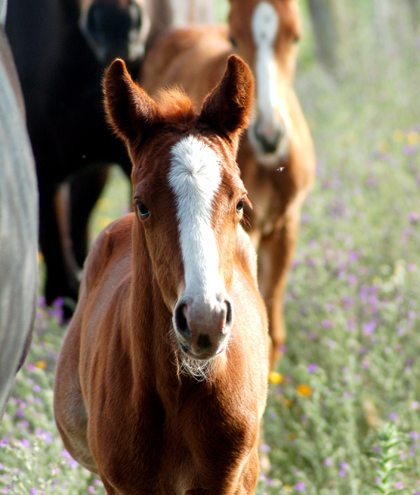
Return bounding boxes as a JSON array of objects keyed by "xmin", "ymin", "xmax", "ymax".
[{"xmin": 199, "ymin": 55, "xmax": 254, "ymax": 144}]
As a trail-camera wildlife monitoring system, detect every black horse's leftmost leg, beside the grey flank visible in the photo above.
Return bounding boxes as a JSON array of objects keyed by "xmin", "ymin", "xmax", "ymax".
[{"xmin": 39, "ymin": 180, "xmax": 79, "ymax": 304}]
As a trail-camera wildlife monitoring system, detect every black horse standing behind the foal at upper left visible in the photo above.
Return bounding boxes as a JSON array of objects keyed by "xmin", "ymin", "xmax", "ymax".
[{"xmin": 6, "ymin": 0, "xmax": 171, "ymax": 310}]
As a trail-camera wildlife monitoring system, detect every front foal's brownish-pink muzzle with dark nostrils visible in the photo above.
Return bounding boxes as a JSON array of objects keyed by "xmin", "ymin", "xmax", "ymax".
[{"xmin": 173, "ymin": 298, "xmax": 233, "ymax": 360}]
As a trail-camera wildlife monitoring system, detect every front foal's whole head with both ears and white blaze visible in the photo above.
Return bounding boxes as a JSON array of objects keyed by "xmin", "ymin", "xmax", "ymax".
[{"xmin": 104, "ymin": 55, "xmax": 253, "ymax": 372}]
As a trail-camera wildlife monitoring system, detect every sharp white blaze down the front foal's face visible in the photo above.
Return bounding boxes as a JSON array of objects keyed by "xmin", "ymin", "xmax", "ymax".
[{"xmin": 169, "ymin": 136, "xmax": 223, "ymax": 306}]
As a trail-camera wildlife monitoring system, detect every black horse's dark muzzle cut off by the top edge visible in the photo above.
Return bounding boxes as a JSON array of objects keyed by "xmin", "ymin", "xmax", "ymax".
[{"xmin": 78, "ymin": 0, "xmax": 150, "ymax": 64}]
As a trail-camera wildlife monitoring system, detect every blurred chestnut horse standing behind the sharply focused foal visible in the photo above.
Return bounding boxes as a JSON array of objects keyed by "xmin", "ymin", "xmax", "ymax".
[{"xmin": 141, "ymin": 0, "xmax": 315, "ymax": 366}]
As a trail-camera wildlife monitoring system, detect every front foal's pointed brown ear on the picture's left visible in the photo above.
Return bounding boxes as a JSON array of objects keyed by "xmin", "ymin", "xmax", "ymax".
[{"xmin": 103, "ymin": 59, "xmax": 161, "ymax": 144}]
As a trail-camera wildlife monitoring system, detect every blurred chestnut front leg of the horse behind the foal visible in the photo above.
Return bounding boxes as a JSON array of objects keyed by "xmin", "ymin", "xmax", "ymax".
[{"xmin": 258, "ymin": 205, "xmax": 300, "ymax": 369}]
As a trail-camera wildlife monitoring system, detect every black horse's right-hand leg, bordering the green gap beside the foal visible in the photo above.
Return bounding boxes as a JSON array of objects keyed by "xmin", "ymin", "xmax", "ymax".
[{"xmin": 70, "ymin": 165, "xmax": 109, "ymax": 266}]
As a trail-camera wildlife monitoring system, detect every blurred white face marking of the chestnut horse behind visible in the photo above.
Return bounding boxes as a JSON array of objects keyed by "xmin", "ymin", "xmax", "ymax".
[{"xmin": 248, "ymin": 1, "xmax": 291, "ymax": 166}]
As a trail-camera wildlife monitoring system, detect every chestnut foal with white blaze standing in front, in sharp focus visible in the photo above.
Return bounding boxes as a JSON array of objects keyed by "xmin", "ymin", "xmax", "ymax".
[{"xmin": 54, "ymin": 56, "xmax": 269, "ymax": 495}]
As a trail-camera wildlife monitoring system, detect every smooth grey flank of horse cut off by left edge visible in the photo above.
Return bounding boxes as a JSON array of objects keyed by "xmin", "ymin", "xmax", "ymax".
[{"xmin": 0, "ymin": 0, "xmax": 38, "ymax": 419}]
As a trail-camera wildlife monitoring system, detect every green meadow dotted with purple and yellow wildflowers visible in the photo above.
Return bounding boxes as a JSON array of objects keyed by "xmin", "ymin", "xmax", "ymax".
[{"xmin": 0, "ymin": 0, "xmax": 420, "ymax": 495}]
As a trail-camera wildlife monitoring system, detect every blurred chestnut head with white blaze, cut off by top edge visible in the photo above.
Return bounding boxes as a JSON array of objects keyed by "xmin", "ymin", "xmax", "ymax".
[{"xmin": 229, "ymin": 0, "xmax": 300, "ymax": 166}]
